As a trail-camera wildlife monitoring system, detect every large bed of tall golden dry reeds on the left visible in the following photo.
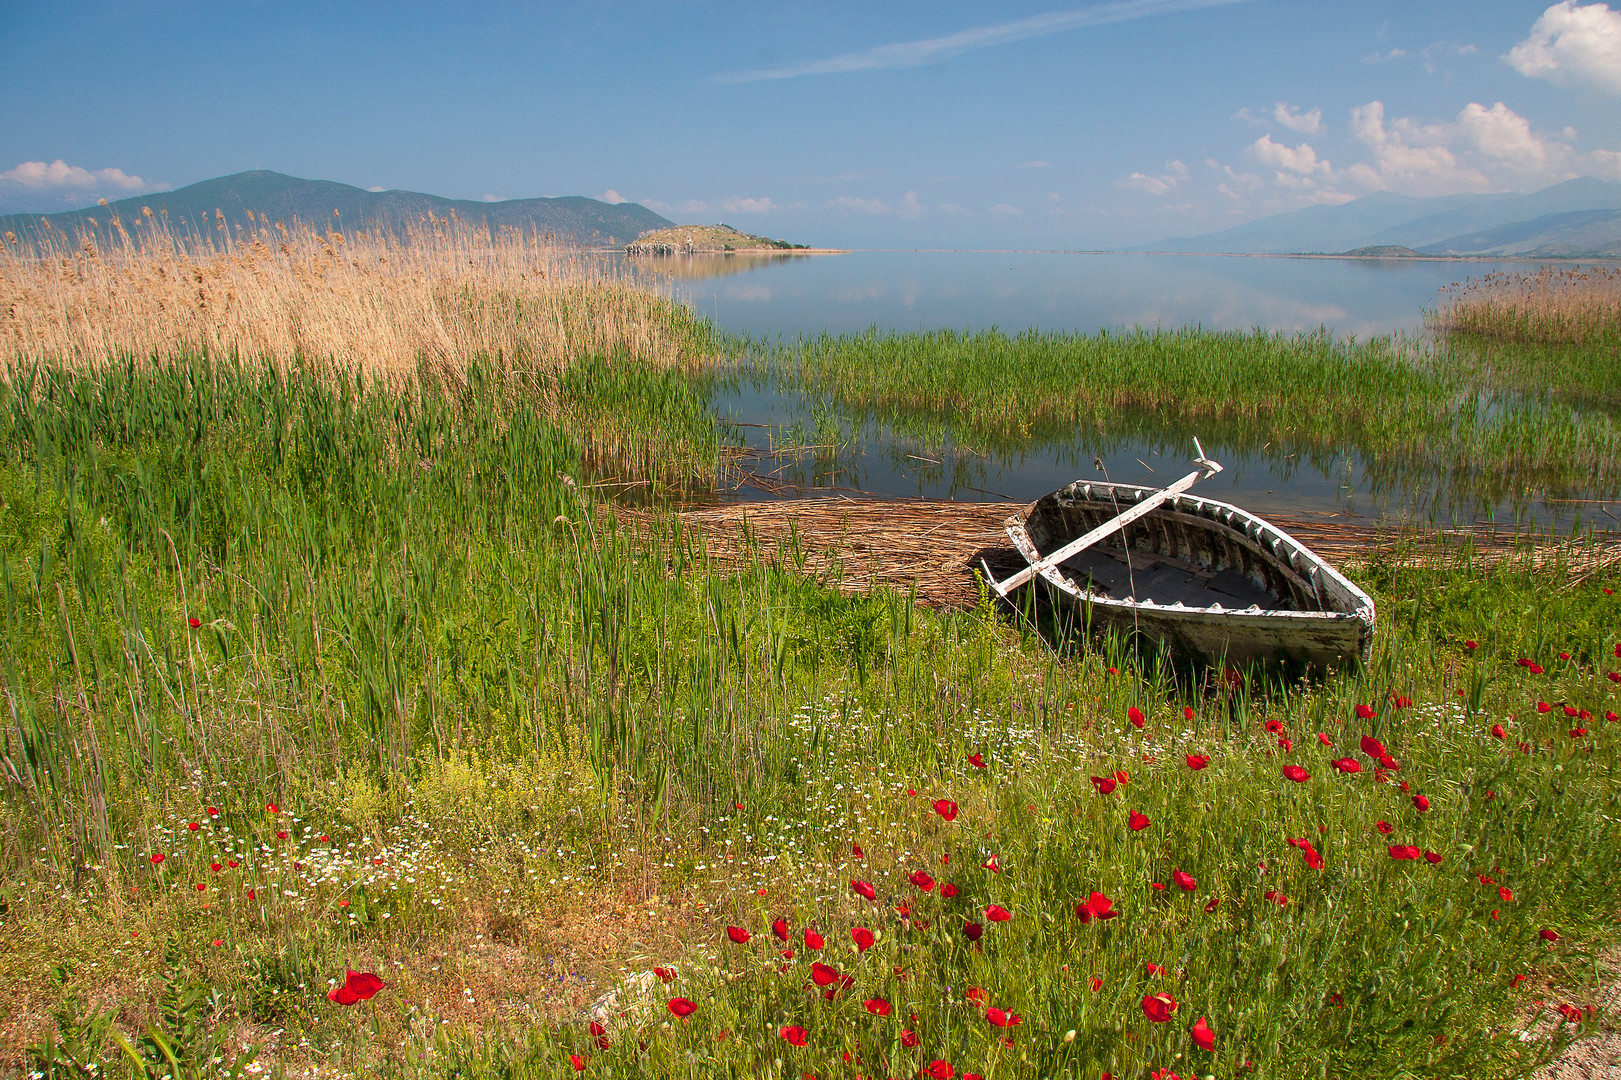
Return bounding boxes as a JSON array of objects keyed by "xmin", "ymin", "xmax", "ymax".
[{"xmin": 0, "ymin": 208, "xmax": 704, "ymax": 381}]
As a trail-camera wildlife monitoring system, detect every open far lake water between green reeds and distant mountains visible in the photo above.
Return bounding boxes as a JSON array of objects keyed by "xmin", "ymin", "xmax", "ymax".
[{"xmin": 638, "ymin": 251, "xmax": 1533, "ymax": 337}]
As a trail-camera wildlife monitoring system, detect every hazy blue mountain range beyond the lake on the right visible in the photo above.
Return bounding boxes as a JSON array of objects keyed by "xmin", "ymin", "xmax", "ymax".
[{"xmin": 1136, "ymin": 177, "xmax": 1621, "ymax": 258}]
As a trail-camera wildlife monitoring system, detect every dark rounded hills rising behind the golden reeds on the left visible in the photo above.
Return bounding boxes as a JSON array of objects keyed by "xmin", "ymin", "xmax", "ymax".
[{"xmin": 0, "ymin": 169, "xmax": 674, "ymax": 246}]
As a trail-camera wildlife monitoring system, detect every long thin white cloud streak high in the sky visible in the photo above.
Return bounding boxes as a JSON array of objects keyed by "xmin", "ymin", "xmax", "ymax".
[{"xmin": 715, "ymin": 0, "xmax": 1238, "ymax": 83}]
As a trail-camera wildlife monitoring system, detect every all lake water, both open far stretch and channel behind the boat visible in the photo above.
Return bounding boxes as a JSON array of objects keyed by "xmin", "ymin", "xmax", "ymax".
[{"xmin": 625, "ymin": 251, "xmax": 1621, "ymax": 524}]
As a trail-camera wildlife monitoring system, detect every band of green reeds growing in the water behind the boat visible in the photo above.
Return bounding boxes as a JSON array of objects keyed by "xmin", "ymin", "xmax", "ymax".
[{"xmin": 749, "ymin": 329, "xmax": 1621, "ymax": 506}]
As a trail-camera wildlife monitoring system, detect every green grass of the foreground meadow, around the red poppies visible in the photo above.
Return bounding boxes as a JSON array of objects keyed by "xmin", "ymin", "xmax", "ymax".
[{"xmin": 0, "ymin": 348, "xmax": 1621, "ymax": 1078}]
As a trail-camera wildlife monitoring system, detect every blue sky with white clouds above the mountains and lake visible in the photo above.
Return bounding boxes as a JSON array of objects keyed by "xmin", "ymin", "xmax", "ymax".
[{"xmin": 0, "ymin": 0, "xmax": 1621, "ymax": 248}]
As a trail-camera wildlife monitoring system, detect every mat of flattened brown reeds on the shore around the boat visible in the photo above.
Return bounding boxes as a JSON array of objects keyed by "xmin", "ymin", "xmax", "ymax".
[{"xmin": 621, "ymin": 496, "xmax": 1595, "ymax": 606}]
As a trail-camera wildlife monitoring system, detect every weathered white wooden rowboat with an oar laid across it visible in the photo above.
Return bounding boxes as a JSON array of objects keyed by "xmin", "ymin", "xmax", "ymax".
[{"xmin": 986, "ymin": 451, "xmax": 1375, "ymax": 671}]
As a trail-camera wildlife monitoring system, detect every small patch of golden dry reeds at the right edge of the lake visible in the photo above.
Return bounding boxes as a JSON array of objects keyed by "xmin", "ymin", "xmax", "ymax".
[{"xmin": 1430, "ymin": 266, "xmax": 1621, "ymax": 344}]
